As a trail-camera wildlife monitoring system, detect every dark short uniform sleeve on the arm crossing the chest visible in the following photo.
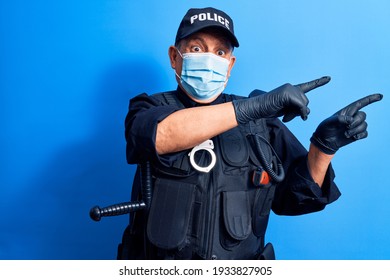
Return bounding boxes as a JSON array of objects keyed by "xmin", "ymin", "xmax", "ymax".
[{"xmin": 125, "ymin": 93, "xmax": 179, "ymax": 164}]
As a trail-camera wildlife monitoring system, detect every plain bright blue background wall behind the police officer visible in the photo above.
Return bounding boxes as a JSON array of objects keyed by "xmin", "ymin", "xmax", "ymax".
[{"xmin": 0, "ymin": 0, "xmax": 390, "ymax": 259}]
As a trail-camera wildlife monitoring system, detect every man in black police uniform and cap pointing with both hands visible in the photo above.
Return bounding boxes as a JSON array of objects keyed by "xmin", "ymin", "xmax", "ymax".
[{"xmin": 118, "ymin": 8, "xmax": 382, "ymax": 259}]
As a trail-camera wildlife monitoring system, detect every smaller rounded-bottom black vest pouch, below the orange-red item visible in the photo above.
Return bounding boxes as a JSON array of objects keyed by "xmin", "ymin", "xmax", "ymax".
[{"xmin": 222, "ymin": 191, "xmax": 252, "ymax": 241}]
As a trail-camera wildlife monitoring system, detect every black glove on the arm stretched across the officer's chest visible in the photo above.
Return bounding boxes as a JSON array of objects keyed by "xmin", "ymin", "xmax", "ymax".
[{"xmin": 233, "ymin": 77, "xmax": 330, "ymax": 124}]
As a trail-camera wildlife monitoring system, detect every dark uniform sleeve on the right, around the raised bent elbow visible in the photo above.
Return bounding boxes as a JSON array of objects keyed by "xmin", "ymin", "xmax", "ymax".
[{"xmin": 268, "ymin": 119, "xmax": 341, "ymax": 215}]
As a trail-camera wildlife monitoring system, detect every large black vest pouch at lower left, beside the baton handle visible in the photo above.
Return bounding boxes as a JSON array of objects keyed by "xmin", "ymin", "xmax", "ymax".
[{"xmin": 147, "ymin": 178, "xmax": 196, "ymax": 250}]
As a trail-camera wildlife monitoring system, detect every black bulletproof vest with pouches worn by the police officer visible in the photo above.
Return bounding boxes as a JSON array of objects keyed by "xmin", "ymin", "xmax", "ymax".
[{"xmin": 126, "ymin": 92, "xmax": 275, "ymax": 259}]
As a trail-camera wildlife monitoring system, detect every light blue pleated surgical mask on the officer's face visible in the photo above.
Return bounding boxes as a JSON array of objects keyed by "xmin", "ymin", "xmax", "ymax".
[{"xmin": 176, "ymin": 50, "xmax": 230, "ymax": 100}]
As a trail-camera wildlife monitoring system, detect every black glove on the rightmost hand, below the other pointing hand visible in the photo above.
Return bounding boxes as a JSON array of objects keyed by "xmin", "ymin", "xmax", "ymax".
[{"xmin": 310, "ymin": 94, "xmax": 383, "ymax": 155}]
